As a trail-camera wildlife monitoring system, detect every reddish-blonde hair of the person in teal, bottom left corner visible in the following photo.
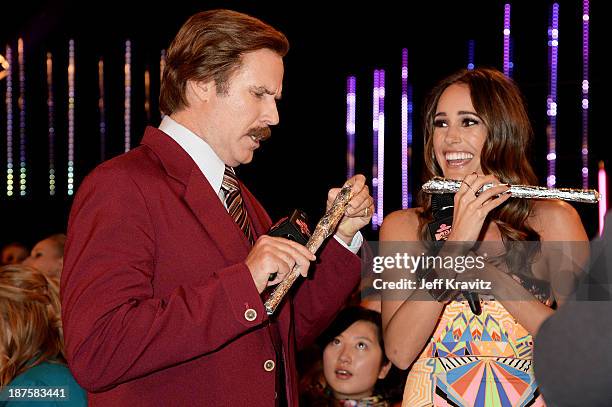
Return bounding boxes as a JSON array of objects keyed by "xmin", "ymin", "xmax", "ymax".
[{"xmin": 0, "ymin": 265, "xmax": 66, "ymax": 388}]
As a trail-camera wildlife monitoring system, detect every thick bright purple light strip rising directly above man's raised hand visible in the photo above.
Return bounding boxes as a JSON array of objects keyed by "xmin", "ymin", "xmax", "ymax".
[{"xmin": 372, "ymin": 69, "xmax": 385, "ymax": 230}]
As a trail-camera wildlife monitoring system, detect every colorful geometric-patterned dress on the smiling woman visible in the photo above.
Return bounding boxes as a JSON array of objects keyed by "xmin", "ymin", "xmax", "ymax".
[{"xmin": 402, "ymin": 277, "xmax": 552, "ymax": 407}]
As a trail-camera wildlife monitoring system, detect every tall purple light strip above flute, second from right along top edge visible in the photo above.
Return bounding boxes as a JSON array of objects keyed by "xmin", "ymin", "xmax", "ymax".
[{"xmin": 546, "ymin": 3, "xmax": 559, "ymax": 188}]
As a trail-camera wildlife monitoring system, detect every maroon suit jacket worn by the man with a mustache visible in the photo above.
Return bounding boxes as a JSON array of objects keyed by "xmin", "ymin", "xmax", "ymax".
[{"xmin": 61, "ymin": 127, "xmax": 360, "ymax": 407}]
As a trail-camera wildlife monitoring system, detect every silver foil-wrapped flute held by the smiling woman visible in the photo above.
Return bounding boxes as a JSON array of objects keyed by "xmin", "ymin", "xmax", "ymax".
[{"xmin": 423, "ymin": 177, "xmax": 599, "ymax": 203}]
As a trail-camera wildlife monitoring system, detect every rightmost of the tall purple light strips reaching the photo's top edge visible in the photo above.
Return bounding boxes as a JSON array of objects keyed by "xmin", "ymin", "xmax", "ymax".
[{"xmin": 581, "ymin": 0, "xmax": 590, "ymax": 189}]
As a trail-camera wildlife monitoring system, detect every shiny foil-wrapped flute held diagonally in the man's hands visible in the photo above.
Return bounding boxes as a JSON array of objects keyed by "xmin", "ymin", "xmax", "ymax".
[{"xmin": 264, "ymin": 183, "xmax": 353, "ymax": 315}]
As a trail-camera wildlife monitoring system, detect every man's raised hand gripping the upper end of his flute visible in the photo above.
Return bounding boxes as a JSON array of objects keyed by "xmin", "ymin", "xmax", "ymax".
[{"xmin": 327, "ymin": 174, "xmax": 374, "ymax": 245}]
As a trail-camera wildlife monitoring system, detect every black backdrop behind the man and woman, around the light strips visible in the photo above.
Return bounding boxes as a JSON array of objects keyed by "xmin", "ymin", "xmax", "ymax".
[{"xmin": 0, "ymin": 0, "xmax": 612, "ymax": 249}]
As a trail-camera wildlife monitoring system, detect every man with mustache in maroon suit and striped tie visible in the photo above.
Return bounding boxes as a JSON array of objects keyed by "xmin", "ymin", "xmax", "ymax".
[{"xmin": 62, "ymin": 10, "xmax": 373, "ymax": 407}]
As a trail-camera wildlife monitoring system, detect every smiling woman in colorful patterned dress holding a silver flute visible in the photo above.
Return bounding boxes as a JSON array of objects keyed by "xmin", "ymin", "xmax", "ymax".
[{"xmin": 380, "ymin": 69, "xmax": 588, "ymax": 407}]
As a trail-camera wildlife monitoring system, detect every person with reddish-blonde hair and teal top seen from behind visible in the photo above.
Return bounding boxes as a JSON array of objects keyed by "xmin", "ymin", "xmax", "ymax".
[{"xmin": 0, "ymin": 265, "xmax": 87, "ymax": 407}]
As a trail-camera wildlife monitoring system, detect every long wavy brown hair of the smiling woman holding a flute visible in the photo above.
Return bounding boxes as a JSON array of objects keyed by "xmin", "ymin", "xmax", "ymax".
[{"xmin": 418, "ymin": 68, "xmax": 540, "ymax": 260}]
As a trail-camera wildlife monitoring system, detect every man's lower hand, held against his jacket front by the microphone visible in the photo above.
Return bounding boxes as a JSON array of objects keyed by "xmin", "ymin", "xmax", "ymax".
[{"xmin": 244, "ymin": 235, "xmax": 316, "ymax": 294}]
